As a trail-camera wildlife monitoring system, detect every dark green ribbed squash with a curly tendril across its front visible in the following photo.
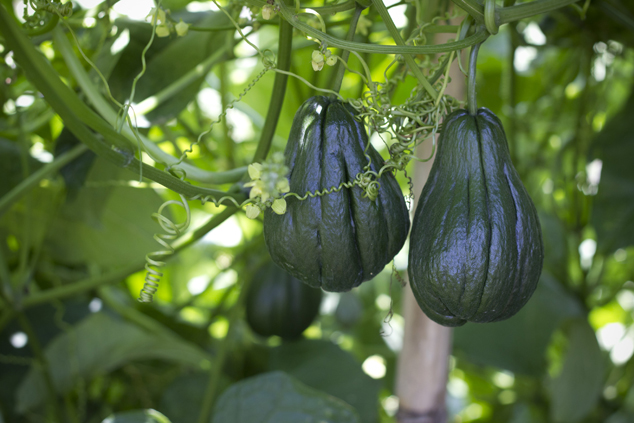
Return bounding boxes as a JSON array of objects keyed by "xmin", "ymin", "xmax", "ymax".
[{"xmin": 264, "ymin": 96, "xmax": 409, "ymax": 291}]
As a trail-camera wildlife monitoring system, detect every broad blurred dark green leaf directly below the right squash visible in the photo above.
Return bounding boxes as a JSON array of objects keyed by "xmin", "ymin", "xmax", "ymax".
[{"xmin": 454, "ymin": 272, "xmax": 583, "ymax": 376}]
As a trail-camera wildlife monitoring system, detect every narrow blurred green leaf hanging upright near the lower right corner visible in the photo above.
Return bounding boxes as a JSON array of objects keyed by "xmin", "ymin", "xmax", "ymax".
[{"xmin": 549, "ymin": 318, "xmax": 604, "ymax": 423}]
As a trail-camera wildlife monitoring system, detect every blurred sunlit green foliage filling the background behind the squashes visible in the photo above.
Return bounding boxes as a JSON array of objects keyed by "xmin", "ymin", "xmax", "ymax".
[{"xmin": 0, "ymin": 0, "xmax": 634, "ymax": 423}]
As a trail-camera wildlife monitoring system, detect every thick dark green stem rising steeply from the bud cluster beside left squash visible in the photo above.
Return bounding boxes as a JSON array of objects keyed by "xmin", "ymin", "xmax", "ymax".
[{"xmin": 253, "ymin": 19, "xmax": 293, "ymax": 163}]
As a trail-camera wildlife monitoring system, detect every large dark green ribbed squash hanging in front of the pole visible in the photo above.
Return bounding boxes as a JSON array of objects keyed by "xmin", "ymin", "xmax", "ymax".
[{"xmin": 408, "ymin": 108, "xmax": 544, "ymax": 326}]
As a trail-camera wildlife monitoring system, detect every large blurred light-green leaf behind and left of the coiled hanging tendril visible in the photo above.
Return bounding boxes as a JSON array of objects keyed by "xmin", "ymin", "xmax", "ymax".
[{"xmin": 47, "ymin": 158, "xmax": 169, "ymax": 267}]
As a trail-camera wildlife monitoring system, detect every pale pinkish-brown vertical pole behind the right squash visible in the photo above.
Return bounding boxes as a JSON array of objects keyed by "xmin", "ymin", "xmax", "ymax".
[{"xmin": 396, "ymin": 29, "xmax": 466, "ymax": 423}]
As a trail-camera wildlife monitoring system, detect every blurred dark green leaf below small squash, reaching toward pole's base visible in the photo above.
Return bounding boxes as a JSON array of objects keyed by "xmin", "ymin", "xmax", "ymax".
[{"xmin": 269, "ymin": 340, "xmax": 381, "ymax": 423}]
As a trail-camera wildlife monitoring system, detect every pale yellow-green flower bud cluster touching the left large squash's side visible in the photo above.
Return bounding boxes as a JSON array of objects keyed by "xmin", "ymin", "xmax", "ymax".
[{"xmin": 244, "ymin": 152, "xmax": 291, "ymax": 219}]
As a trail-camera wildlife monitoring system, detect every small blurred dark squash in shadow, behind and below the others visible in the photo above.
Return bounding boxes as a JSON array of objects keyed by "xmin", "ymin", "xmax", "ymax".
[{"xmin": 245, "ymin": 263, "xmax": 322, "ymax": 340}]
